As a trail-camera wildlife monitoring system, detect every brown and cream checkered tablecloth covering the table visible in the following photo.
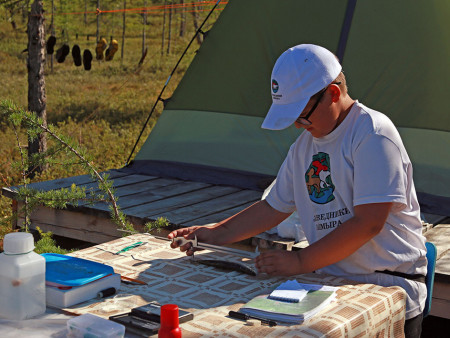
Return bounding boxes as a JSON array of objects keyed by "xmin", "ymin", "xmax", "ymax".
[{"xmin": 64, "ymin": 234, "xmax": 406, "ymax": 337}]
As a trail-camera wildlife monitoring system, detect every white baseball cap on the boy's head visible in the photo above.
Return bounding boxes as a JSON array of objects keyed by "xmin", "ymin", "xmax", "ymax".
[{"xmin": 261, "ymin": 44, "xmax": 342, "ymax": 130}]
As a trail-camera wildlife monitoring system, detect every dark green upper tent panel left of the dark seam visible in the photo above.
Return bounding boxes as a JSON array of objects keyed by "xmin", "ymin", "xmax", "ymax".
[{"xmin": 166, "ymin": 0, "xmax": 346, "ymax": 117}]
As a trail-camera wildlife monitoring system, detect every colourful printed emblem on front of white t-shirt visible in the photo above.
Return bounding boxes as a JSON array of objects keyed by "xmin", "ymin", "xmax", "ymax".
[{"xmin": 305, "ymin": 152, "xmax": 335, "ymax": 204}]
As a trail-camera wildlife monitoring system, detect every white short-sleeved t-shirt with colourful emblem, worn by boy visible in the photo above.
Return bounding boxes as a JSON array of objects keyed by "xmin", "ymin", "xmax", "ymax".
[{"xmin": 266, "ymin": 101, "xmax": 426, "ymax": 319}]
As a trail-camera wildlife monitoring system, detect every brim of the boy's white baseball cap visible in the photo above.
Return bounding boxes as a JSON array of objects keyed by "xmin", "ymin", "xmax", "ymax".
[{"xmin": 261, "ymin": 97, "xmax": 310, "ymax": 130}]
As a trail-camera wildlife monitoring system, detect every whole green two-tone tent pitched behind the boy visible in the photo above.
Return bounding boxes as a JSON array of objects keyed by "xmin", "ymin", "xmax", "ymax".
[{"xmin": 129, "ymin": 0, "xmax": 450, "ymax": 215}]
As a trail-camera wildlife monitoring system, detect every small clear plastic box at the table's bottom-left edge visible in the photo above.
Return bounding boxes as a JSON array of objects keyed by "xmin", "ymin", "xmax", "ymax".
[{"xmin": 67, "ymin": 313, "xmax": 125, "ymax": 338}]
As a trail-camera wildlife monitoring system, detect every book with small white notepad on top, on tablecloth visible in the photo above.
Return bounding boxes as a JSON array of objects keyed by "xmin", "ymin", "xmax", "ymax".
[{"xmin": 239, "ymin": 281, "xmax": 339, "ymax": 324}]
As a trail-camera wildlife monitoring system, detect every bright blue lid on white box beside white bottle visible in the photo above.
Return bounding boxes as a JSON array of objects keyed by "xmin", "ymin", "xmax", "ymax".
[{"xmin": 42, "ymin": 253, "xmax": 114, "ymax": 286}]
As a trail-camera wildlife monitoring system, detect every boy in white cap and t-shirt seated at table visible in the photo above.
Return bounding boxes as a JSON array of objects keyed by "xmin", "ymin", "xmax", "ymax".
[{"xmin": 169, "ymin": 44, "xmax": 427, "ymax": 337}]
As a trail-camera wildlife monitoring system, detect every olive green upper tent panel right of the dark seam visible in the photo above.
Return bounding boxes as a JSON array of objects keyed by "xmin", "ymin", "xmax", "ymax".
[{"xmin": 343, "ymin": 0, "xmax": 450, "ymax": 132}]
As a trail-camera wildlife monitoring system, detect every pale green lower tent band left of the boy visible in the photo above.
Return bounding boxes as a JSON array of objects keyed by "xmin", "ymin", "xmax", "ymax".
[{"xmin": 135, "ymin": 110, "xmax": 298, "ymax": 177}]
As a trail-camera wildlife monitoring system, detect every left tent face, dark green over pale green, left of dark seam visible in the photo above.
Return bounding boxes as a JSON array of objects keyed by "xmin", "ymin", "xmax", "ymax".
[{"xmin": 135, "ymin": 0, "xmax": 346, "ymax": 174}]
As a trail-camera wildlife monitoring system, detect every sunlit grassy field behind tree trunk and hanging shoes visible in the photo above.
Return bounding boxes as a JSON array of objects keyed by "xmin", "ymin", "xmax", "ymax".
[{"xmin": 0, "ymin": 0, "xmax": 224, "ymax": 239}]
